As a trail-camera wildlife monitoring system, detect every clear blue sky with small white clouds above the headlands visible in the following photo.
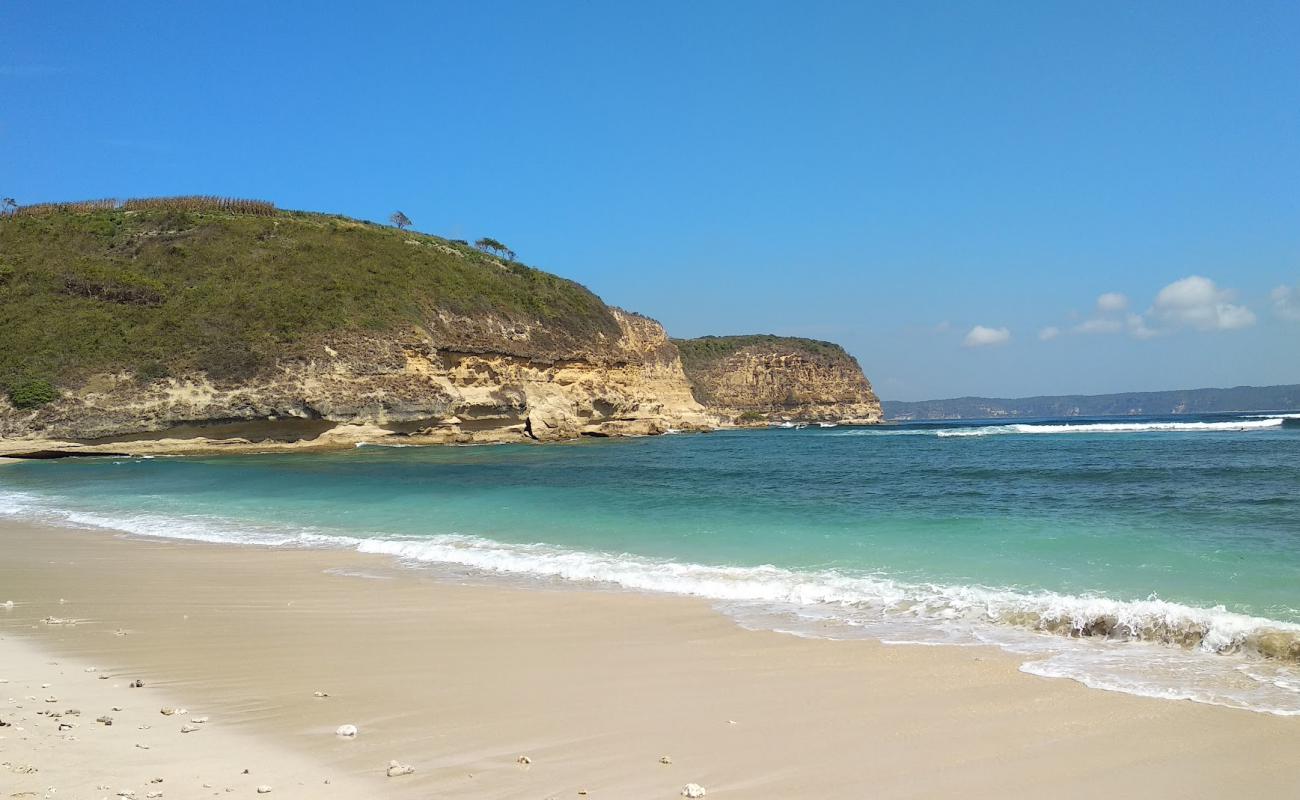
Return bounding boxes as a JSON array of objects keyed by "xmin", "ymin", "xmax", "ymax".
[{"xmin": 0, "ymin": 0, "xmax": 1300, "ymax": 399}]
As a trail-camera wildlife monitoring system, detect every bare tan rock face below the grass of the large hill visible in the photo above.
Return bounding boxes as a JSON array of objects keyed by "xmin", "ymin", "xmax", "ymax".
[{"xmin": 0, "ymin": 310, "xmax": 710, "ymax": 451}]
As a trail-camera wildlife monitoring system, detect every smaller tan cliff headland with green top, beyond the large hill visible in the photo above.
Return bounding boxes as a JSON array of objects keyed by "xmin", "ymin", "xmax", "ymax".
[{"xmin": 676, "ymin": 336, "xmax": 881, "ymax": 424}]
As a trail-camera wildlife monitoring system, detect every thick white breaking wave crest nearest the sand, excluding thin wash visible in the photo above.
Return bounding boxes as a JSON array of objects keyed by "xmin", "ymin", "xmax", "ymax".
[{"xmin": 358, "ymin": 536, "xmax": 1300, "ymax": 663}]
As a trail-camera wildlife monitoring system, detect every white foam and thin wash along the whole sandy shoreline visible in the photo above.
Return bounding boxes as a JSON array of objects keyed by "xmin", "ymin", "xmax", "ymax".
[{"xmin": 0, "ymin": 492, "xmax": 1300, "ymax": 715}]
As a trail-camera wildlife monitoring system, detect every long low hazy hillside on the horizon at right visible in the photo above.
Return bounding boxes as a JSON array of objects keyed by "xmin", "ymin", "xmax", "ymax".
[{"xmin": 883, "ymin": 384, "xmax": 1300, "ymax": 420}]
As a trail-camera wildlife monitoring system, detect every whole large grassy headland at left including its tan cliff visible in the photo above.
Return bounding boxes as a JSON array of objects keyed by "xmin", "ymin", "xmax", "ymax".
[{"xmin": 0, "ymin": 199, "xmax": 711, "ymax": 453}]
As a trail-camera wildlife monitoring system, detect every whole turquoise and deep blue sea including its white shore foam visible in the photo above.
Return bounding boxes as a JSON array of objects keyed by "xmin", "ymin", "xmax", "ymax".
[{"xmin": 0, "ymin": 414, "xmax": 1300, "ymax": 714}]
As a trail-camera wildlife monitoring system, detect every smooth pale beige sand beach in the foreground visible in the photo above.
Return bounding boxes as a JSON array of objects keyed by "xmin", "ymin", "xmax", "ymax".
[{"xmin": 0, "ymin": 523, "xmax": 1300, "ymax": 799}]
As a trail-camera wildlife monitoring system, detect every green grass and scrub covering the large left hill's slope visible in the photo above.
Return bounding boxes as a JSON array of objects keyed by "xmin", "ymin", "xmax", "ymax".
[{"xmin": 0, "ymin": 199, "xmax": 620, "ymax": 395}]
